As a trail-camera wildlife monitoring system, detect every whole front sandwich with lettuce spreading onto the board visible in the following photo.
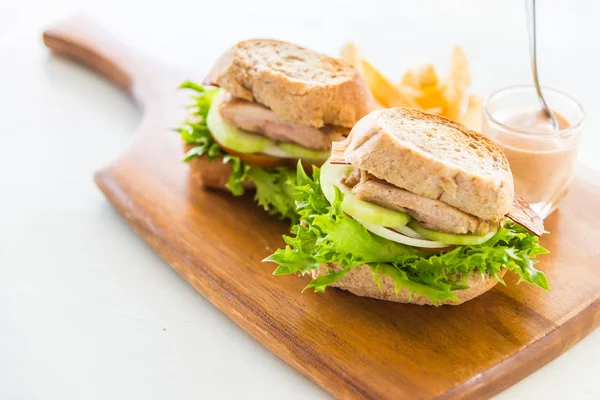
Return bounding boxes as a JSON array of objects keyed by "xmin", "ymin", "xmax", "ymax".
[{"xmin": 265, "ymin": 108, "xmax": 549, "ymax": 305}]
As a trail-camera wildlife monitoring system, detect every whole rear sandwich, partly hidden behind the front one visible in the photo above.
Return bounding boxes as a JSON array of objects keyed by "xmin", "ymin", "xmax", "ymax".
[{"xmin": 178, "ymin": 39, "xmax": 374, "ymax": 219}]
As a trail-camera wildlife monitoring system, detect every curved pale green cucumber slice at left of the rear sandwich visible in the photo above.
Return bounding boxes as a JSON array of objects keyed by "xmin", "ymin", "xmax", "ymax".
[{"xmin": 206, "ymin": 89, "xmax": 275, "ymax": 153}]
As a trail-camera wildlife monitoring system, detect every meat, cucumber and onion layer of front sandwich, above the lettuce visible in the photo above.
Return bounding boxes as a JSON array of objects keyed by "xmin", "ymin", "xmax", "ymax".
[{"xmin": 320, "ymin": 162, "xmax": 499, "ymax": 249}]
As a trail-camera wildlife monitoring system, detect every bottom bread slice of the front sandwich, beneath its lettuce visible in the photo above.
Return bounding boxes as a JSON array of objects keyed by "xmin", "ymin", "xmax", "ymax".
[{"xmin": 311, "ymin": 263, "xmax": 506, "ymax": 306}]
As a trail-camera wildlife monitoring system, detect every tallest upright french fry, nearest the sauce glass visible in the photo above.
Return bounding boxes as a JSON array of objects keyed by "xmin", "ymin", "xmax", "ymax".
[{"xmin": 443, "ymin": 46, "xmax": 471, "ymax": 120}]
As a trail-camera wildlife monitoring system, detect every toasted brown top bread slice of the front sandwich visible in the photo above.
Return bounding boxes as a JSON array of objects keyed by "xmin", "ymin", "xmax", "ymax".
[{"xmin": 344, "ymin": 108, "xmax": 514, "ymax": 221}]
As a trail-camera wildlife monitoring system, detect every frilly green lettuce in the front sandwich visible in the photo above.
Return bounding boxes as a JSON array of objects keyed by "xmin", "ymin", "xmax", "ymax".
[{"xmin": 264, "ymin": 167, "xmax": 549, "ymax": 305}]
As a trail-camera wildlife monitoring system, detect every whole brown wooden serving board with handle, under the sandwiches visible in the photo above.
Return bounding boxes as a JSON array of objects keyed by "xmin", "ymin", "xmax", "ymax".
[{"xmin": 44, "ymin": 18, "xmax": 600, "ymax": 399}]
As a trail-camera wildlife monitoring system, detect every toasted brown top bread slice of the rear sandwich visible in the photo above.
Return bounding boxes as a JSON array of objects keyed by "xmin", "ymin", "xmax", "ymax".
[{"xmin": 208, "ymin": 39, "xmax": 374, "ymax": 128}]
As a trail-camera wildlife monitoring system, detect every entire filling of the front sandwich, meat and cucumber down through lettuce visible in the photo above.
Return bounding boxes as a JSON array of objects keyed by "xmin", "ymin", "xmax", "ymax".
[{"xmin": 264, "ymin": 162, "xmax": 549, "ymax": 304}]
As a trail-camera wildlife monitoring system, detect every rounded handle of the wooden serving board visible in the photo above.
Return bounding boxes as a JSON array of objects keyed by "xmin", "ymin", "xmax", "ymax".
[{"xmin": 43, "ymin": 16, "xmax": 160, "ymax": 105}]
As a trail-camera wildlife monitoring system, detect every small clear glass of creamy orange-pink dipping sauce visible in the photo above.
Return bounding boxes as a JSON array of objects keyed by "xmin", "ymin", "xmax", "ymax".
[{"xmin": 482, "ymin": 85, "xmax": 585, "ymax": 218}]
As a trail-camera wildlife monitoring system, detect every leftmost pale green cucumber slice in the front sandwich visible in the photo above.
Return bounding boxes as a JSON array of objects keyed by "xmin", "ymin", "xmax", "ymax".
[{"xmin": 321, "ymin": 160, "xmax": 410, "ymax": 227}]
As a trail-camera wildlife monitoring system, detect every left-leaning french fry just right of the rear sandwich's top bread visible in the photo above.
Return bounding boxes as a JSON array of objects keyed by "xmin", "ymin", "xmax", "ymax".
[{"xmin": 362, "ymin": 58, "xmax": 419, "ymax": 108}]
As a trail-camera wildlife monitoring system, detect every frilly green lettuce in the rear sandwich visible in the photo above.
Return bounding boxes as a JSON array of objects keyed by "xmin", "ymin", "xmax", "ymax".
[{"xmin": 176, "ymin": 81, "xmax": 297, "ymax": 222}]
